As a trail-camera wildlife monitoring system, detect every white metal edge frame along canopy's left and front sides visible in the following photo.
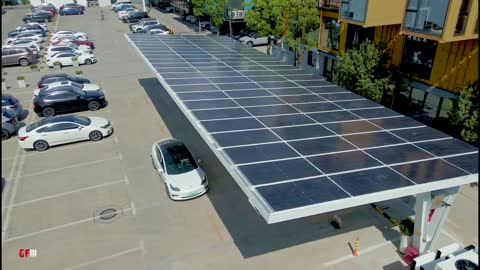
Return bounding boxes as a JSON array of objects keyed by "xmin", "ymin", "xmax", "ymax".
[{"xmin": 125, "ymin": 34, "xmax": 478, "ymax": 234}]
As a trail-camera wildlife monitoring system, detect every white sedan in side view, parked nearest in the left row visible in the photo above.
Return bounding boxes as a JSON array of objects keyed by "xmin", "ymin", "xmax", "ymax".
[{"xmin": 18, "ymin": 115, "xmax": 113, "ymax": 151}]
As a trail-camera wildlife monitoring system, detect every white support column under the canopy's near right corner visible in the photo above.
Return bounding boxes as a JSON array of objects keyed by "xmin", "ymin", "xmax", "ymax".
[{"xmin": 413, "ymin": 187, "xmax": 459, "ymax": 254}]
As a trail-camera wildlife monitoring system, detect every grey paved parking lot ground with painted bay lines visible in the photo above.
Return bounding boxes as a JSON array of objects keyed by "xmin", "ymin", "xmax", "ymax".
[{"xmin": 2, "ymin": 4, "xmax": 478, "ymax": 270}]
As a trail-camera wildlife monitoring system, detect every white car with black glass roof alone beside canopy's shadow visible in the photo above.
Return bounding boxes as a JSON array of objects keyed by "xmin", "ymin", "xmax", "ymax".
[{"xmin": 150, "ymin": 138, "xmax": 208, "ymax": 201}]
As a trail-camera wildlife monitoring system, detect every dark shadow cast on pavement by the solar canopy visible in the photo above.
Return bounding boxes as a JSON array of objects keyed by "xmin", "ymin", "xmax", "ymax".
[{"xmin": 139, "ymin": 78, "xmax": 399, "ymax": 258}]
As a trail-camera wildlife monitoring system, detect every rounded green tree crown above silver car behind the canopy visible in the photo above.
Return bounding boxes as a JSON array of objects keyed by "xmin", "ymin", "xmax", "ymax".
[{"xmin": 244, "ymin": 0, "xmax": 284, "ymax": 36}]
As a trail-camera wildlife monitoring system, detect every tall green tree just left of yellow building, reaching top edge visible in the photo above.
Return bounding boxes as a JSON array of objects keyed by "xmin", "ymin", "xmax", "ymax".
[{"xmin": 276, "ymin": 0, "xmax": 320, "ymax": 63}]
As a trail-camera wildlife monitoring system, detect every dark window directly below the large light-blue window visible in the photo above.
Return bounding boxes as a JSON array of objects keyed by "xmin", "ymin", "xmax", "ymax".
[{"xmin": 400, "ymin": 36, "xmax": 437, "ymax": 80}]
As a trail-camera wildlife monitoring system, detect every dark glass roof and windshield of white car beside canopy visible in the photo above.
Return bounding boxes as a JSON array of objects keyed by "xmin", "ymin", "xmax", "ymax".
[{"xmin": 162, "ymin": 143, "xmax": 198, "ymax": 175}]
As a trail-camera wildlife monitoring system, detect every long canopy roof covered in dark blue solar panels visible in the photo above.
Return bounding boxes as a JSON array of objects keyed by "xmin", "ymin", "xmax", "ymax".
[{"xmin": 127, "ymin": 35, "xmax": 478, "ymax": 223}]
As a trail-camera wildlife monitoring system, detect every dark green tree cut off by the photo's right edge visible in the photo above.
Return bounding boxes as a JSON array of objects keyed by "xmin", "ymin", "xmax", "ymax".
[{"xmin": 448, "ymin": 82, "xmax": 480, "ymax": 142}]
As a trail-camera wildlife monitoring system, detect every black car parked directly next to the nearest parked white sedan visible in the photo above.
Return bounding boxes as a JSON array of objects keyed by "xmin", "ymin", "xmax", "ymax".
[{"xmin": 33, "ymin": 87, "xmax": 108, "ymax": 117}]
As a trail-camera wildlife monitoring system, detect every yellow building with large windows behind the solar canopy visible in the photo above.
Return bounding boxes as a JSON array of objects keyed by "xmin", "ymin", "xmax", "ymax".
[{"xmin": 306, "ymin": 0, "xmax": 478, "ymax": 126}]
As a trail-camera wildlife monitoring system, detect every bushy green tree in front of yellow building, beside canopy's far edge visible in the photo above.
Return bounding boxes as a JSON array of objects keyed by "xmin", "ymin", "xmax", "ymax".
[{"xmin": 335, "ymin": 40, "xmax": 392, "ymax": 102}]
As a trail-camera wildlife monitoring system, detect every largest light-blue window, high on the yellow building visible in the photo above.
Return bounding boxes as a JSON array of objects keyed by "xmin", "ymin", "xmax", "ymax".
[{"xmin": 403, "ymin": 0, "xmax": 449, "ymax": 36}]
